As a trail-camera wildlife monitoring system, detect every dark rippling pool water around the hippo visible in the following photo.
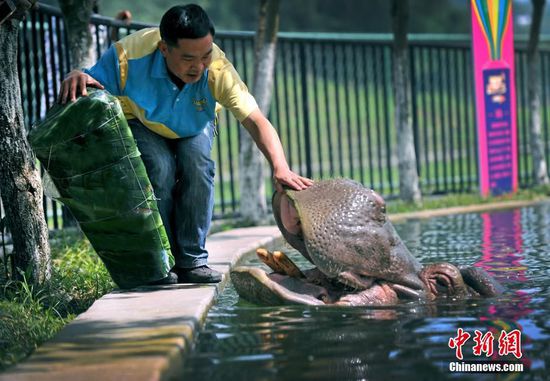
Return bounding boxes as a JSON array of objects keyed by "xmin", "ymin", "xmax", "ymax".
[{"xmin": 184, "ymin": 203, "xmax": 550, "ymax": 381}]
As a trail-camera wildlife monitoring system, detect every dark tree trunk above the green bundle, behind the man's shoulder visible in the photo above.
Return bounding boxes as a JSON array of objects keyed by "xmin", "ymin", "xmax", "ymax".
[{"xmin": 59, "ymin": 0, "xmax": 97, "ymax": 69}]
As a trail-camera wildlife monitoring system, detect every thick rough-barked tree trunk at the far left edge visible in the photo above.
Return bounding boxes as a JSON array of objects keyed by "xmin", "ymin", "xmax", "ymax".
[{"xmin": 0, "ymin": 20, "xmax": 50, "ymax": 283}]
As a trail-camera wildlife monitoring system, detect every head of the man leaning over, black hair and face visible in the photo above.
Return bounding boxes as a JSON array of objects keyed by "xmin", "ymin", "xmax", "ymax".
[{"xmin": 159, "ymin": 4, "xmax": 215, "ymax": 83}]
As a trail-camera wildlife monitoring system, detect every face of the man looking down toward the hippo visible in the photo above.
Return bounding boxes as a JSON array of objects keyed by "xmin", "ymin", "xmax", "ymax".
[{"xmin": 159, "ymin": 33, "xmax": 212, "ymax": 83}]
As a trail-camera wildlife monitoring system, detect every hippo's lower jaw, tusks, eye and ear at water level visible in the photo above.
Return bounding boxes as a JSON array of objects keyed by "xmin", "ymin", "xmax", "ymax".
[{"xmin": 231, "ymin": 248, "xmax": 504, "ymax": 306}]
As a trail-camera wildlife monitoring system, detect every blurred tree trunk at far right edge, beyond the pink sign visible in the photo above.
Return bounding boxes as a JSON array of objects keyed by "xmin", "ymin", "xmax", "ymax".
[{"xmin": 527, "ymin": 0, "xmax": 550, "ymax": 185}]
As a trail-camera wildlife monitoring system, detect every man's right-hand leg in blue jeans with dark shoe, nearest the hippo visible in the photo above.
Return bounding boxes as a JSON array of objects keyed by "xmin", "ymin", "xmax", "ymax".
[{"xmin": 173, "ymin": 122, "xmax": 221, "ymax": 282}]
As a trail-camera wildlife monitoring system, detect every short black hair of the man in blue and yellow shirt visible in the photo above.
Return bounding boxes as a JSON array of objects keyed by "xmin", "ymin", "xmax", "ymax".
[{"xmin": 160, "ymin": 4, "xmax": 216, "ymax": 46}]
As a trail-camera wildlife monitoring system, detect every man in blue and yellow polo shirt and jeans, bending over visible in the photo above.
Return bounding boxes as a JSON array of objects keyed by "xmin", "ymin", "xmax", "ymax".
[{"xmin": 59, "ymin": 4, "xmax": 312, "ymax": 283}]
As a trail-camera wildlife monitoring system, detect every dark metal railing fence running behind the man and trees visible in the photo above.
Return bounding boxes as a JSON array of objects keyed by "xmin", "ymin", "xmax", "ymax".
[{"xmin": 4, "ymin": 6, "xmax": 550, "ymax": 235}]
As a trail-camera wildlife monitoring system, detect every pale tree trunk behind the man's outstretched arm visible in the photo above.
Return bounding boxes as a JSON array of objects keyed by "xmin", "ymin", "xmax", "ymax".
[{"xmin": 239, "ymin": 0, "xmax": 279, "ymax": 224}]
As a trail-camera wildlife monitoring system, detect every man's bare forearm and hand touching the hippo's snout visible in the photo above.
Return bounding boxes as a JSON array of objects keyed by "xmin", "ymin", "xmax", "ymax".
[{"xmin": 242, "ymin": 109, "xmax": 313, "ymax": 192}]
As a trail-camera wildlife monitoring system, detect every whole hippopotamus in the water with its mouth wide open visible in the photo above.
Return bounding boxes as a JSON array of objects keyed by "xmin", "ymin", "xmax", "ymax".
[{"xmin": 231, "ymin": 179, "xmax": 504, "ymax": 306}]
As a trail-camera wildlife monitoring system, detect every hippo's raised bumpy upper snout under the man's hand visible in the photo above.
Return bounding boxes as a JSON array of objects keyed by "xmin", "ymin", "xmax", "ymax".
[{"xmin": 273, "ymin": 179, "xmax": 424, "ymax": 293}]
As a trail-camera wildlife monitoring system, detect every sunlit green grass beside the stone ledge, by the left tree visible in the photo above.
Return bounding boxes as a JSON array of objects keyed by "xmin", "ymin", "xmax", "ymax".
[{"xmin": 0, "ymin": 233, "xmax": 114, "ymax": 370}]
